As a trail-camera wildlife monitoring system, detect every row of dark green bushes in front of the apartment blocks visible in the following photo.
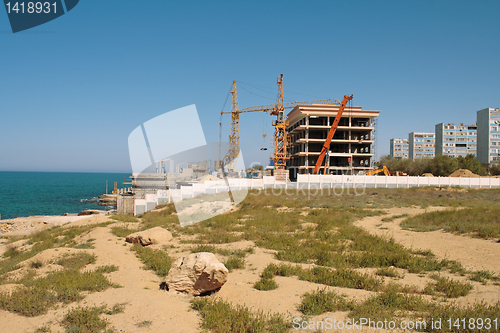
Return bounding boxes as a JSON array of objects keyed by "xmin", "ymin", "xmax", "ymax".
[{"xmin": 379, "ymin": 154, "xmax": 488, "ymax": 177}]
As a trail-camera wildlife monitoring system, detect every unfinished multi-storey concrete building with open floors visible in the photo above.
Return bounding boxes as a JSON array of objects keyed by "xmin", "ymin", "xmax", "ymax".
[{"xmin": 287, "ymin": 104, "xmax": 380, "ymax": 174}]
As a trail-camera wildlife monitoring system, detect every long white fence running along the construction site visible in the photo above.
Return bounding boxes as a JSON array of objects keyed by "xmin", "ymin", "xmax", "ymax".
[{"xmin": 133, "ymin": 175, "xmax": 500, "ymax": 215}]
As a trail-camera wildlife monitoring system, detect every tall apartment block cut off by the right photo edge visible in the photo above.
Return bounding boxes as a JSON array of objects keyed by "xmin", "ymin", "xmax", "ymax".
[{"xmin": 477, "ymin": 108, "xmax": 500, "ymax": 164}]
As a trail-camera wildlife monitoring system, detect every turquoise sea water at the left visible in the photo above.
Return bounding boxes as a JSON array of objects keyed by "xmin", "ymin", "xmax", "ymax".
[{"xmin": 0, "ymin": 171, "xmax": 130, "ymax": 220}]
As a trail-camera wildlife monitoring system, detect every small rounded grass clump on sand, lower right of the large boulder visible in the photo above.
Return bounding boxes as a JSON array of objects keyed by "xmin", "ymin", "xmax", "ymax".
[{"xmin": 299, "ymin": 289, "xmax": 354, "ymax": 316}]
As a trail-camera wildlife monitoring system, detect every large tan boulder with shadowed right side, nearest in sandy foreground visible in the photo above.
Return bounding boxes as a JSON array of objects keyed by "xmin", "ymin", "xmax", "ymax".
[{"xmin": 165, "ymin": 252, "xmax": 228, "ymax": 296}]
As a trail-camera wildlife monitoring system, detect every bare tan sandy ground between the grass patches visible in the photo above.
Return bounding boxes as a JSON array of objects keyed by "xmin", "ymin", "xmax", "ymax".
[{"xmin": 0, "ymin": 208, "xmax": 500, "ymax": 333}]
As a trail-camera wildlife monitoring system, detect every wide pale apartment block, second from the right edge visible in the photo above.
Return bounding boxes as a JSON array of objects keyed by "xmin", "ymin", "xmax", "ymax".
[{"xmin": 436, "ymin": 123, "xmax": 476, "ymax": 157}]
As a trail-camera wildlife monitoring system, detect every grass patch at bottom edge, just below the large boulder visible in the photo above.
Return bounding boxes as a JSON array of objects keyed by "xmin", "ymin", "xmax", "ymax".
[{"xmin": 191, "ymin": 297, "xmax": 291, "ymax": 333}]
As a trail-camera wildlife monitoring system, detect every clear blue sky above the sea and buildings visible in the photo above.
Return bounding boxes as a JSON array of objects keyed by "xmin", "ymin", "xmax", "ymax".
[{"xmin": 0, "ymin": 0, "xmax": 500, "ymax": 172}]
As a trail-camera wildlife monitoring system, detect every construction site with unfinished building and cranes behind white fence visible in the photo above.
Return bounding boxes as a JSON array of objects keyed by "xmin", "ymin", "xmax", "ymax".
[{"xmin": 126, "ymin": 74, "xmax": 380, "ymax": 198}]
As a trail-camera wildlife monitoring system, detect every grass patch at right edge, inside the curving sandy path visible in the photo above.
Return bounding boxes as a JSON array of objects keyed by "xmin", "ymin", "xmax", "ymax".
[{"xmin": 401, "ymin": 205, "xmax": 500, "ymax": 239}]
